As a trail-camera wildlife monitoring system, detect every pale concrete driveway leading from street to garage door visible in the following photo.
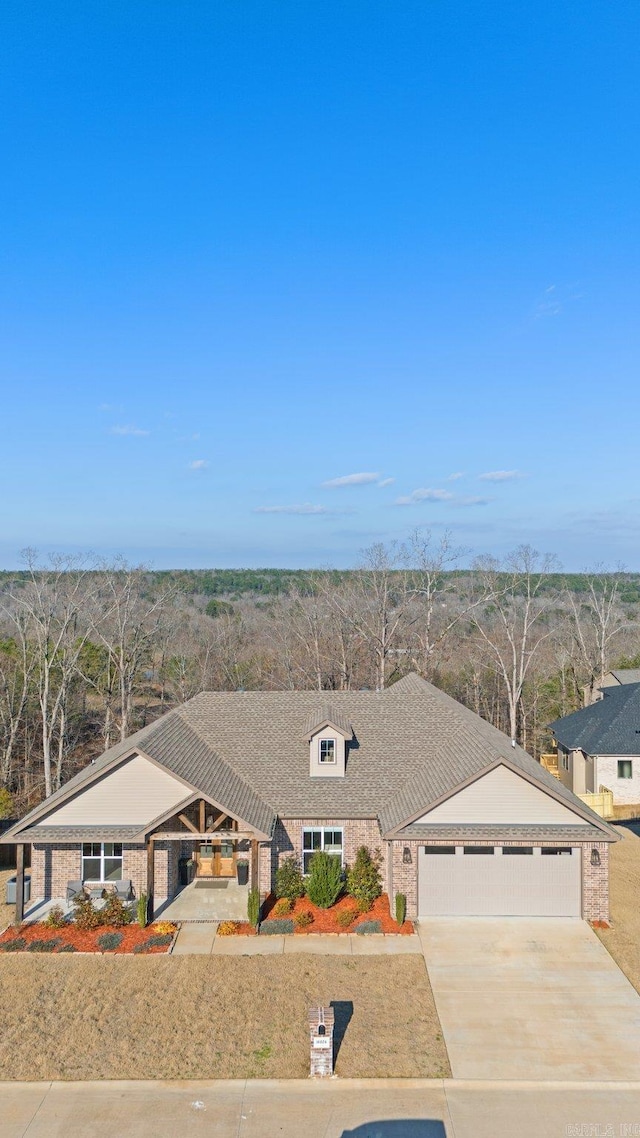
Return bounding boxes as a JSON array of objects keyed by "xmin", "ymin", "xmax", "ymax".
[{"xmin": 419, "ymin": 917, "xmax": 640, "ymax": 1081}]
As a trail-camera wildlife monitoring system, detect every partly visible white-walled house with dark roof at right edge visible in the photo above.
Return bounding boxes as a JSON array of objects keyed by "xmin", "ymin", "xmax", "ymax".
[{"xmin": 549, "ymin": 682, "xmax": 640, "ymax": 805}]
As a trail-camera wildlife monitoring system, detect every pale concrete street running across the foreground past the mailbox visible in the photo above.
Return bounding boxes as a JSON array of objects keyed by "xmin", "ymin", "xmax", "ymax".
[{"xmin": 0, "ymin": 1079, "xmax": 640, "ymax": 1138}]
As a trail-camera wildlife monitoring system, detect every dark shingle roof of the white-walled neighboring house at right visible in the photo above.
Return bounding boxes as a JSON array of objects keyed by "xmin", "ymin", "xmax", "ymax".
[{"xmin": 549, "ymin": 684, "xmax": 640, "ymax": 754}]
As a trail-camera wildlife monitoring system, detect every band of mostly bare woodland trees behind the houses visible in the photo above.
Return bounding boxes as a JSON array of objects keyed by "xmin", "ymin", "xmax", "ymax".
[{"xmin": 0, "ymin": 530, "xmax": 640, "ymax": 816}]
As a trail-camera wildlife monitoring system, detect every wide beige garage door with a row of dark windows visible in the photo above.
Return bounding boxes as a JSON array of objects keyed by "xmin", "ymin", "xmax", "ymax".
[{"xmin": 418, "ymin": 846, "xmax": 581, "ymax": 917}]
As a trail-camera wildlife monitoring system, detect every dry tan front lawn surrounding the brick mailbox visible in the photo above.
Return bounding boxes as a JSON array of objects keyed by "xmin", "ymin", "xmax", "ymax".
[{"xmin": 0, "ymin": 955, "xmax": 450, "ymax": 1080}]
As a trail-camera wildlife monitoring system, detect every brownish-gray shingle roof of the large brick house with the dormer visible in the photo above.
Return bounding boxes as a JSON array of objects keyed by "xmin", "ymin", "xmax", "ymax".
[{"xmin": 7, "ymin": 674, "xmax": 608, "ymax": 835}]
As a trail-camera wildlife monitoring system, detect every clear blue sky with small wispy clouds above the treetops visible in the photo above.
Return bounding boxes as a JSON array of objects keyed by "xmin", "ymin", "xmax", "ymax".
[{"xmin": 0, "ymin": 0, "xmax": 640, "ymax": 570}]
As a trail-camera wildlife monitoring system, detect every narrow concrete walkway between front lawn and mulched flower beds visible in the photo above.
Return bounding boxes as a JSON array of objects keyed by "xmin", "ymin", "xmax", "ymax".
[{"xmin": 168, "ymin": 921, "xmax": 422, "ymax": 956}]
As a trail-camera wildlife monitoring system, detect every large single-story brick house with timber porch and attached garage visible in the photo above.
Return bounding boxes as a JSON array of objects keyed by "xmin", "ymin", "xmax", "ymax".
[{"xmin": 1, "ymin": 675, "xmax": 617, "ymax": 920}]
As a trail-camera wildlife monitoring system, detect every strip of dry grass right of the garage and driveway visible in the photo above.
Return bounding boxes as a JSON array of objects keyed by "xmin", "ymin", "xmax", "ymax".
[{"xmin": 596, "ymin": 826, "xmax": 640, "ymax": 992}]
